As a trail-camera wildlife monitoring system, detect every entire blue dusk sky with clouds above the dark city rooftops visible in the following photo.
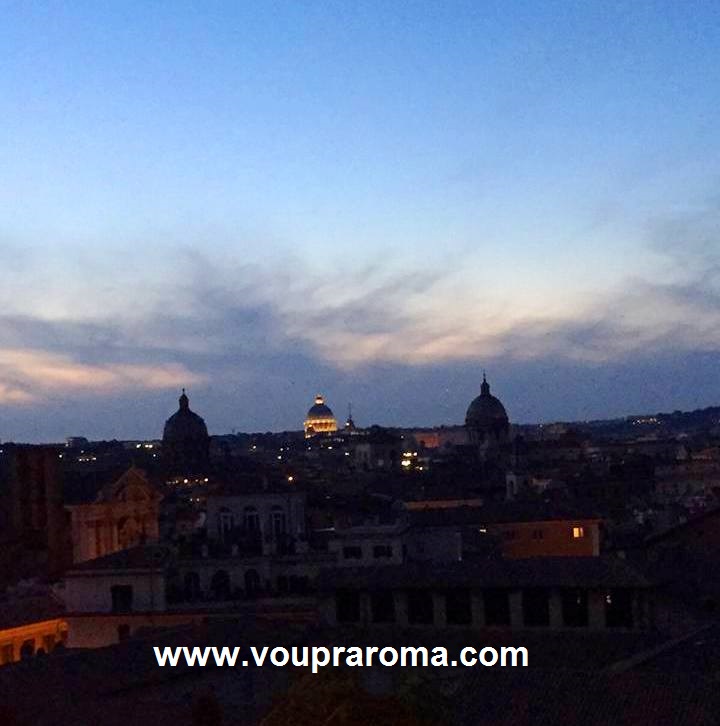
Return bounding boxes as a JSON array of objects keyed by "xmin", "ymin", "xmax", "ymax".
[{"xmin": 0, "ymin": 0, "xmax": 720, "ymax": 442}]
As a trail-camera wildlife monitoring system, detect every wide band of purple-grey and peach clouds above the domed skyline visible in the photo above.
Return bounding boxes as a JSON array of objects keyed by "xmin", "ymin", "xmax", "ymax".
[{"xmin": 0, "ymin": 202, "xmax": 720, "ymax": 436}]
